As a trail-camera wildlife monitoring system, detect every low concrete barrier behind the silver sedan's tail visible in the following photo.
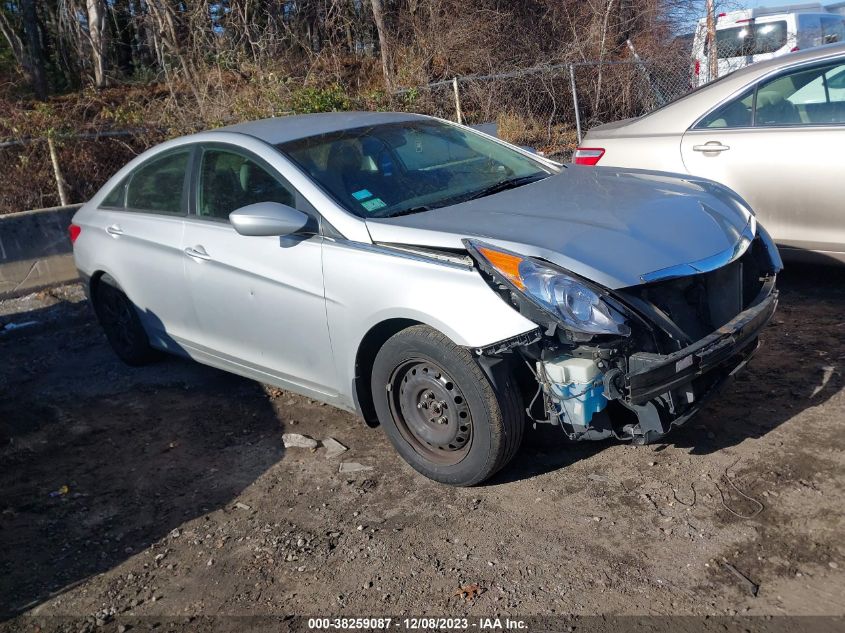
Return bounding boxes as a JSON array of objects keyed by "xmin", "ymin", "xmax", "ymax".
[{"xmin": 0, "ymin": 205, "xmax": 81, "ymax": 299}]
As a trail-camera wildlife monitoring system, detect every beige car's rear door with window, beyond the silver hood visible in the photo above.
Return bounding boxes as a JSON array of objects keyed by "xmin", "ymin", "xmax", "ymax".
[{"xmin": 681, "ymin": 60, "xmax": 845, "ymax": 252}]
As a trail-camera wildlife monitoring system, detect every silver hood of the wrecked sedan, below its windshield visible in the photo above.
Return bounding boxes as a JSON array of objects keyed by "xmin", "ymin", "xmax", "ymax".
[{"xmin": 367, "ymin": 166, "xmax": 751, "ymax": 289}]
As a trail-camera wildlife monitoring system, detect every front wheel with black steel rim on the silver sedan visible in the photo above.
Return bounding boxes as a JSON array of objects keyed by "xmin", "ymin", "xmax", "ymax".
[{"xmin": 372, "ymin": 325, "xmax": 525, "ymax": 486}]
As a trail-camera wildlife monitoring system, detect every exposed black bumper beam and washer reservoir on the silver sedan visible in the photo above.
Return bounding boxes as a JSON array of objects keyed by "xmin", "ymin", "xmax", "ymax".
[{"xmin": 523, "ymin": 269, "xmax": 778, "ymax": 444}]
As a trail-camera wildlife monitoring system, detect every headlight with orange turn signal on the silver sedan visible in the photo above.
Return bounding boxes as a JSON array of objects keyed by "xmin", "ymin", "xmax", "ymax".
[{"xmin": 465, "ymin": 240, "xmax": 631, "ymax": 336}]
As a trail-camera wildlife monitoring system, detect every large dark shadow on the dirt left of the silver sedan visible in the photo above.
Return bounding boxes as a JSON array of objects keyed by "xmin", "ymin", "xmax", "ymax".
[{"xmin": 0, "ymin": 302, "xmax": 283, "ymax": 621}]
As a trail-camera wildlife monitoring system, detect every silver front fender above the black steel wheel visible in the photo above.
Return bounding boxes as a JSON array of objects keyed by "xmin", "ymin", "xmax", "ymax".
[{"xmin": 323, "ymin": 241, "xmax": 537, "ymax": 405}]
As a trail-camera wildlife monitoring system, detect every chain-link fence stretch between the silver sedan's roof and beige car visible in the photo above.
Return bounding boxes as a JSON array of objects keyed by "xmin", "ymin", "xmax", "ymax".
[{"xmin": 397, "ymin": 60, "xmax": 692, "ymax": 160}]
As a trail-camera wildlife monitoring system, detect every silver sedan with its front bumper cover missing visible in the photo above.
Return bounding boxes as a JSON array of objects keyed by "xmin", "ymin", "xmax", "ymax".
[{"xmin": 70, "ymin": 113, "xmax": 782, "ymax": 485}]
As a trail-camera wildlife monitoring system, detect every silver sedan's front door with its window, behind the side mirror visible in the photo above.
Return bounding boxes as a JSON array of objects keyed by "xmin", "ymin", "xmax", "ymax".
[{"xmin": 183, "ymin": 144, "xmax": 336, "ymax": 395}]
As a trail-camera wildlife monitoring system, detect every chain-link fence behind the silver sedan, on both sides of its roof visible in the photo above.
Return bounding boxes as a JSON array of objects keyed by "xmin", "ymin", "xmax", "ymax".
[{"xmin": 0, "ymin": 60, "xmax": 691, "ymax": 213}]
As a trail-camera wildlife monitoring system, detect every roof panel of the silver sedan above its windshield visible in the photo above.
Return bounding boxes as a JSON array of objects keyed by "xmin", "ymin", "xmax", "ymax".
[{"xmin": 213, "ymin": 112, "xmax": 430, "ymax": 145}]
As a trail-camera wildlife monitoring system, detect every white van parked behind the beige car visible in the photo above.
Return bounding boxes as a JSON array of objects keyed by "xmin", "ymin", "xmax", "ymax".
[{"xmin": 692, "ymin": 4, "xmax": 845, "ymax": 88}]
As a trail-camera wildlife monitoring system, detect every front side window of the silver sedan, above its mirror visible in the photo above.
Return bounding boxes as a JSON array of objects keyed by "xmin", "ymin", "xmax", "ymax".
[{"xmin": 197, "ymin": 149, "xmax": 296, "ymax": 221}]
